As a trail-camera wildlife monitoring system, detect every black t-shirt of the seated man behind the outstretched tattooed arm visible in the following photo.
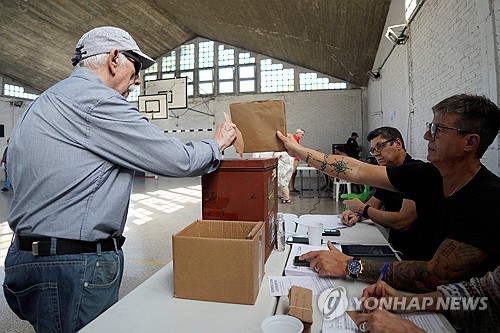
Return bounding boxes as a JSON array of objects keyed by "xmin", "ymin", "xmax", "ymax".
[{"xmin": 373, "ymin": 154, "xmax": 428, "ymax": 260}]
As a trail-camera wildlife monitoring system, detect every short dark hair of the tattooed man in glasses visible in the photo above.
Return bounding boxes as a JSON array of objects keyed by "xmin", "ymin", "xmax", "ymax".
[{"xmin": 432, "ymin": 94, "xmax": 500, "ymax": 158}]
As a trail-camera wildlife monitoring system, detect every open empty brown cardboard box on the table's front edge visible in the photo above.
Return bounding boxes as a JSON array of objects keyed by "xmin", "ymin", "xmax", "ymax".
[{"xmin": 172, "ymin": 220, "xmax": 265, "ymax": 304}]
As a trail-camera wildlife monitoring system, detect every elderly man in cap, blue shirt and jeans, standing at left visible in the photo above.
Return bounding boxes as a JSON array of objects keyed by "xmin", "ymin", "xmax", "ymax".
[{"xmin": 4, "ymin": 27, "xmax": 236, "ymax": 332}]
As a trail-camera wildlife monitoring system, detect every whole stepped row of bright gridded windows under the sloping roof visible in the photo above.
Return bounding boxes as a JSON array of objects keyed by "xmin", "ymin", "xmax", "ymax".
[{"xmin": 144, "ymin": 37, "xmax": 347, "ymax": 97}]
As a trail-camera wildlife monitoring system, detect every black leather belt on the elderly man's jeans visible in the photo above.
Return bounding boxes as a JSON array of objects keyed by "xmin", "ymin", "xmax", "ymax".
[{"xmin": 16, "ymin": 235, "xmax": 125, "ymax": 256}]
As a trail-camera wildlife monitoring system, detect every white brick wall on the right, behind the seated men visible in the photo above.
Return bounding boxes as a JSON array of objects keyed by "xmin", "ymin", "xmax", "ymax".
[{"xmin": 368, "ymin": 0, "xmax": 500, "ymax": 174}]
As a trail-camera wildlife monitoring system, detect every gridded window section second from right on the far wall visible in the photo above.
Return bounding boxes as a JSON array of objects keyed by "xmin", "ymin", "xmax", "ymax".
[{"xmin": 260, "ymin": 59, "xmax": 295, "ymax": 92}]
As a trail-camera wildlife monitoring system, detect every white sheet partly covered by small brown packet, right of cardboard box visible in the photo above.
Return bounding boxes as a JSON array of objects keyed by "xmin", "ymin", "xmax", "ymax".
[{"xmin": 268, "ymin": 276, "xmax": 335, "ymax": 296}]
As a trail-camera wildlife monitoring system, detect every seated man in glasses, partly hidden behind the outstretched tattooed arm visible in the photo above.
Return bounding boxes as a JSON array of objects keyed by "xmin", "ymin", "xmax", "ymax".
[{"xmin": 342, "ymin": 126, "xmax": 426, "ymax": 260}]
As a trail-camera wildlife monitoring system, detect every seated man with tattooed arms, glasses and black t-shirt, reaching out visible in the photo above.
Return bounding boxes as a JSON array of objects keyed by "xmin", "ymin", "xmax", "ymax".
[{"xmin": 277, "ymin": 94, "xmax": 500, "ymax": 292}]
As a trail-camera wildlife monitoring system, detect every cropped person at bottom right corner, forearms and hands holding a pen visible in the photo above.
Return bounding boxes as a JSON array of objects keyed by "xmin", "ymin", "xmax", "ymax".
[{"xmin": 351, "ymin": 266, "xmax": 500, "ymax": 333}]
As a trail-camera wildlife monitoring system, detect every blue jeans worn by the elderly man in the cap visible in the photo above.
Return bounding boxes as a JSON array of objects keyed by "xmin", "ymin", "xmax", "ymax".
[{"xmin": 3, "ymin": 243, "xmax": 123, "ymax": 332}]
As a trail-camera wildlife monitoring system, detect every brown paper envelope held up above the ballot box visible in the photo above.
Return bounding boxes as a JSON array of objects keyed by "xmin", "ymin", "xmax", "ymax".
[{"xmin": 229, "ymin": 100, "xmax": 286, "ymax": 153}]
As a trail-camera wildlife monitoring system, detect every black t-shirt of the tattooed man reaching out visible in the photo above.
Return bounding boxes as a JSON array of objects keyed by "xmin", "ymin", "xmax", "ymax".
[{"xmin": 387, "ymin": 163, "xmax": 500, "ymax": 280}]
